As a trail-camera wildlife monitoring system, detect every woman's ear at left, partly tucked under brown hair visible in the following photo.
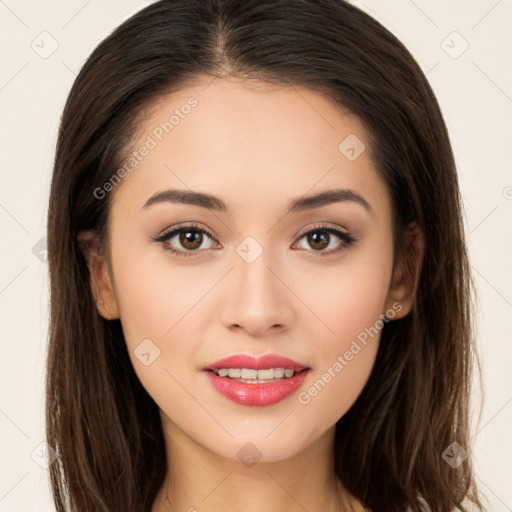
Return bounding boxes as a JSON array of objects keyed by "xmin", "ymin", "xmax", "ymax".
[{"xmin": 77, "ymin": 230, "xmax": 120, "ymax": 320}]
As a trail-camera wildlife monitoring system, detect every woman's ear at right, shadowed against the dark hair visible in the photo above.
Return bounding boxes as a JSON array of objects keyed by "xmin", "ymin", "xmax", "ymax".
[{"xmin": 386, "ymin": 222, "xmax": 425, "ymax": 319}]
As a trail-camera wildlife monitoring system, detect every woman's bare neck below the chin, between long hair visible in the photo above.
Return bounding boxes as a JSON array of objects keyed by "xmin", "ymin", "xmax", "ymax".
[{"xmin": 152, "ymin": 419, "xmax": 364, "ymax": 512}]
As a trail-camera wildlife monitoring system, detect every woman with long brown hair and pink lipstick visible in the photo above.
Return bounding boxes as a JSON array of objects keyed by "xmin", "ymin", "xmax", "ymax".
[{"xmin": 47, "ymin": 0, "xmax": 482, "ymax": 512}]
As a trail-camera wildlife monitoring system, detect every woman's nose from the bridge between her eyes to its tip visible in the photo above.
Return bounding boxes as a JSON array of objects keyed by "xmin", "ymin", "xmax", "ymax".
[{"xmin": 223, "ymin": 236, "xmax": 292, "ymax": 334}]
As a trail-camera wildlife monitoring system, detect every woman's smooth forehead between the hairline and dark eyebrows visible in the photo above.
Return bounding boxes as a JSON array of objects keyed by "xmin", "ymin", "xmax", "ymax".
[{"xmin": 115, "ymin": 77, "xmax": 388, "ymax": 217}]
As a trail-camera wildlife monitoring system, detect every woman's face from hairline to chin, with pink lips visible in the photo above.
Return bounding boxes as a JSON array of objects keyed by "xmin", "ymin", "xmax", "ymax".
[{"xmin": 83, "ymin": 78, "xmax": 408, "ymax": 462}]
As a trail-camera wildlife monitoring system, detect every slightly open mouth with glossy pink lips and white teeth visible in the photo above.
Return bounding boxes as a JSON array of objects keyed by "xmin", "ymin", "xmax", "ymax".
[{"xmin": 203, "ymin": 354, "xmax": 311, "ymax": 406}]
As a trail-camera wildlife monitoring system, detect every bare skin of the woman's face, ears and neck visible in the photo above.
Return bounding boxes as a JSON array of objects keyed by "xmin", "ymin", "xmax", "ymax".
[{"xmin": 81, "ymin": 77, "xmax": 422, "ymax": 512}]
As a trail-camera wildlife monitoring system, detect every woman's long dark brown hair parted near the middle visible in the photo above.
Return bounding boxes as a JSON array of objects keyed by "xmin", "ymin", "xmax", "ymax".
[{"xmin": 46, "ymin": 0, "xmax": 483, "ymax": 512}]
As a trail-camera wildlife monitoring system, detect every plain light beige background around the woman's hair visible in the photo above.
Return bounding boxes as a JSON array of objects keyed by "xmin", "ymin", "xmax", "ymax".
[{"xmin": 0, "ymin": 0, "xmax": 512, "ymax": 512}]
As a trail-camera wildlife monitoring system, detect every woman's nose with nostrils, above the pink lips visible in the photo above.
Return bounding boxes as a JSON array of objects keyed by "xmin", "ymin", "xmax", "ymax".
[{"xmin": 221, "ymin": 243, "xmax": 294, "ymax": 337}]
